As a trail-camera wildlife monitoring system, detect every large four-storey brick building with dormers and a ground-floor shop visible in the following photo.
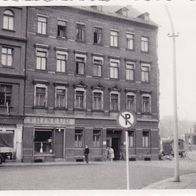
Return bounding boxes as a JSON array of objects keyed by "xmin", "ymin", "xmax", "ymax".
[{"xmin": 23, "ymin": 7, "xmax": 159, "ymax": 161}]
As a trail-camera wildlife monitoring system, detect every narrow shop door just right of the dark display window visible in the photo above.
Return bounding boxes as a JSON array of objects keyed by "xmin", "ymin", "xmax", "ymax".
[{"xmin": 55, "ymin": 129, "xmax": 64, "ymax": 159}]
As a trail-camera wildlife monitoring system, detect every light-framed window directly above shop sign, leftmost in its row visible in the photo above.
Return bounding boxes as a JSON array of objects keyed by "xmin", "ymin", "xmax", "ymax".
[{"xmin": 34, "ymin": 84, "xmax": 47, "ymax": 107}]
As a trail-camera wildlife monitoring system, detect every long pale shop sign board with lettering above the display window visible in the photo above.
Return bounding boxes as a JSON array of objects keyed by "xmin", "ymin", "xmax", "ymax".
[{"xmin": 25, "ymin": 117, "xmax": 75, "ymax": 125}]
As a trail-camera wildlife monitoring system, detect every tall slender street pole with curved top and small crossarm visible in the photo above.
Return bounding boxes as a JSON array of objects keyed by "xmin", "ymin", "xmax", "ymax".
[{"xmin": 165, "ymin": 6, "xmax": 180, "ymax": 182}]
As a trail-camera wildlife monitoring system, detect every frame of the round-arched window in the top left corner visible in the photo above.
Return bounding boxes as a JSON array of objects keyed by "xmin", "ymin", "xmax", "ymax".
[{"xmin": 3, "ymin": 9, "xmax": 15, "ymax": 31}]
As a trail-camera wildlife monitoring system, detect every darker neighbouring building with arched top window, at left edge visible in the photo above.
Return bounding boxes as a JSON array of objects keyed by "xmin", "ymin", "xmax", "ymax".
[{"xmin": 0, "ymin": 7, "xmax": 26, "ymax": 161}]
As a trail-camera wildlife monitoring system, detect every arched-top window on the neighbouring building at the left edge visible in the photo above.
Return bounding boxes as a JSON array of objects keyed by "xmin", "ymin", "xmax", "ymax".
[{"xmin": 3, "ymin": 10, "xmax": 14, "ymax": 30}]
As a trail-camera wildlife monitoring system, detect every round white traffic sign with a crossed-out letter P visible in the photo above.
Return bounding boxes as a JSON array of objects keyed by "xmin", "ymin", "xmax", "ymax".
[{"xmin": 118, "ymin": 112, "xmax": 136, "ymax": 128}]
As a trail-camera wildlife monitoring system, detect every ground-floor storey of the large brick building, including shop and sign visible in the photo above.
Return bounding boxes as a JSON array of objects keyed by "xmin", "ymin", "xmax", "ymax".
[{"xmin": 23, "ymin": 116, "xmax": 159, "ymax": 162}]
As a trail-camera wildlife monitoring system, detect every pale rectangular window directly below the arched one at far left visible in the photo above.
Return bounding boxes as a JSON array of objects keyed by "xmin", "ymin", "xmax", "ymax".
[{"xmin": 1, "ymin": 47, "xmax": 13, "ymax": 67}]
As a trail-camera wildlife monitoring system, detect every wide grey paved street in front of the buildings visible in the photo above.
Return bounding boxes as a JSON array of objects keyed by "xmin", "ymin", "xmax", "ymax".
[{"xmin": 0, "ymin": 159, "xmax": 196, "ymax": 190}]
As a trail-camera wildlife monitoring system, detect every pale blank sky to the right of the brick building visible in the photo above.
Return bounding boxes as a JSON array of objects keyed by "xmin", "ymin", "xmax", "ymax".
[{"xmin": 132, "ymin": 1, "xmax": 196, "ymax": 121}]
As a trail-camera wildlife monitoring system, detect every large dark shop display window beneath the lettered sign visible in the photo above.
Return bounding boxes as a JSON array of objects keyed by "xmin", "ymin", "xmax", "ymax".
[{"xmin": 34, "ymin": 129, "xmax": 53, "ymax": 154}]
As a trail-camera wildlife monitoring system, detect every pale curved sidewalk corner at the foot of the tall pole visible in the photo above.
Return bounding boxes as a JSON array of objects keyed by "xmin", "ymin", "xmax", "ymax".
[{"xmin": 143, "ymin": 173, "xmax": 196, "ymax": 189}]
